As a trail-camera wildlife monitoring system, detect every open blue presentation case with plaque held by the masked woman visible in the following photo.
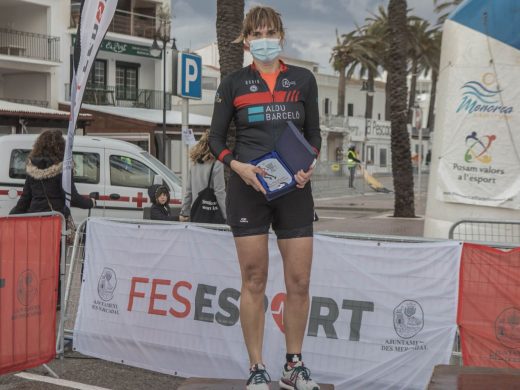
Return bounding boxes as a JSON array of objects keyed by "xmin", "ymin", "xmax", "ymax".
[{"xmin": 251, "ymin": 121, "xmax": 317, "ymax": 200}]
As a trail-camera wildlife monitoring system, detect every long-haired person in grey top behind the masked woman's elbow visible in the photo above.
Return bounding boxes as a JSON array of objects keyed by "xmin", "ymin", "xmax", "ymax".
[{"xmin": 179, "ymin": 130, "xmax": 226, "ymax": 222}]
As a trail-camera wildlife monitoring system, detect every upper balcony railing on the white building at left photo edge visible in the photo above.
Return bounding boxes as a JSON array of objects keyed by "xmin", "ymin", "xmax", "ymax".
[{"xmin": 0, "ymin": 28, "xmax": 60, "ymax": 62}]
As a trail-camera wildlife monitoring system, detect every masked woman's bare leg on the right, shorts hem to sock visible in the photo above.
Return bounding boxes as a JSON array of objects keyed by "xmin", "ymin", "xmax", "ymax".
[{"xmin": 278, "ymin": 237, "xmax": 313, "ymax": 353}]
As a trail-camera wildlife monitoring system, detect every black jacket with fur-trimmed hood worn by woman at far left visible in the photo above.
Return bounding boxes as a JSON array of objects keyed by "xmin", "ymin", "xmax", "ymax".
[{"xmin": 10, "ymin": 158, "xmax": 94, "ymax": 216}]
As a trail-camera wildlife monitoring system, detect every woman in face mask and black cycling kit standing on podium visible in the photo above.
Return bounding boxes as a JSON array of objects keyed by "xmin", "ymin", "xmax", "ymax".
[{"xmin": 210, "ymin": 7, "xmax": 321, "ymax": 390}]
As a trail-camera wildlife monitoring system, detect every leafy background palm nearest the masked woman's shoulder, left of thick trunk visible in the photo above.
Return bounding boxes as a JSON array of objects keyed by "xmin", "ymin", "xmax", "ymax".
[{"xmin": 330, "ymin": 29, "xmax": 373, "ymax": 116}]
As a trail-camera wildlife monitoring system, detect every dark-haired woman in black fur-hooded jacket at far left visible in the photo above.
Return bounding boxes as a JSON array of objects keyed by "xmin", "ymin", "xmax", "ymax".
[{"xmin": 10, "ymin": 130, "xmax": 96, "ymax": 217}]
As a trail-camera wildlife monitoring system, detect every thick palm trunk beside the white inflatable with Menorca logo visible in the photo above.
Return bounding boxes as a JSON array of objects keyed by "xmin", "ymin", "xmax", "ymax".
[{"xmin": 387, "ymin": 0, "xmax": 415, "ymax": 218}]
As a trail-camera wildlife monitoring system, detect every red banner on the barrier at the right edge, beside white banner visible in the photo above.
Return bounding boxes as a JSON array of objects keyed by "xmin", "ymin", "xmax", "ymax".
[{"xmin": 457, "ymin": 244, "xmax": 520, "ymax": 368}]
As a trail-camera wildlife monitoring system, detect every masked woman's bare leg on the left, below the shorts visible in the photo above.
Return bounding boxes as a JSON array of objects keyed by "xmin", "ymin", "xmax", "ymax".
[{"xmin": 235, "ymin": 234, "xmax": 269, "ymax": 366}]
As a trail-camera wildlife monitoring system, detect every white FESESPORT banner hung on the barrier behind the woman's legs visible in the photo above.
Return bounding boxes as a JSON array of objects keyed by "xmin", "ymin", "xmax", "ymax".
[{"xmin": 74, "ymin": 219, "xmax": 461, "ymax": 390}]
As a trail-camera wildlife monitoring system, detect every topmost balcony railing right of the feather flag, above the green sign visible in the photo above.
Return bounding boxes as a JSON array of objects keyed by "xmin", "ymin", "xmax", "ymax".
[{"xmin": 70, "ymin": 2, "xmax": 160, "ymax": 39}]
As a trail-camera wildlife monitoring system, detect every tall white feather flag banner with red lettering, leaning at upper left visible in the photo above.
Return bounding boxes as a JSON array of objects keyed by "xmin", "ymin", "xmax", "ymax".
[{"xmin": 62, "ymin": 0, "xmax": 117, "ymax": 207}]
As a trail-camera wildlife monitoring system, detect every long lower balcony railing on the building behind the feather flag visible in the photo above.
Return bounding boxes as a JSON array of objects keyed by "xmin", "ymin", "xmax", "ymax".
[{"xmin": 65, "ymin": 84, "xmax": 172, "ymax": 110}]
